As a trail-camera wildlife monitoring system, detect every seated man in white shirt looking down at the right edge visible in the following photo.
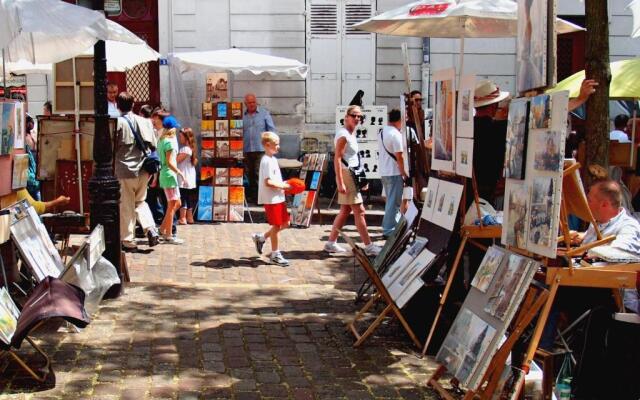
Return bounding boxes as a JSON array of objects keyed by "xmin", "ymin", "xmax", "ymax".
[{"xmin": 540, "ymin": 180, "xmax": 640, "ymax": 399}]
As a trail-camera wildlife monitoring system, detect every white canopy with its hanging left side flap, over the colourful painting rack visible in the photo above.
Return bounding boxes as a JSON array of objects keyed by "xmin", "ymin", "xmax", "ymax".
[{"xmin": 168, "ymin": 48, "xmax": 309, "ymax": 131}]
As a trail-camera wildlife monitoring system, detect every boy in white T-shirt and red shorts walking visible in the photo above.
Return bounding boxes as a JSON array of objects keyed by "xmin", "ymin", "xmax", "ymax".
[{"xmin": 252, "ymin": 132, "xmax": 290, "ymax": 267}]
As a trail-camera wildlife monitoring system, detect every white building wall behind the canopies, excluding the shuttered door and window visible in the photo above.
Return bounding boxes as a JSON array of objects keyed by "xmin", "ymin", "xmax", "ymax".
[{"xmin": 151, "ymin": 0, "xmax": 640, "ymax": 132}]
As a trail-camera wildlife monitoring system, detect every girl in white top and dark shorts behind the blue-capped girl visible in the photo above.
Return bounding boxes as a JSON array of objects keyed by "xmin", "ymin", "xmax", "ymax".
[{"xmin": 177, "ymin": 128, "xmax": 198, "ymax": 225}]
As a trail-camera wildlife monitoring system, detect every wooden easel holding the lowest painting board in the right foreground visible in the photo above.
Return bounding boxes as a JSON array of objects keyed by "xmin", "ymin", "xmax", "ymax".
[{"xmin": 427, "ymin": 283, "xmax": 549, "ymax": 400}]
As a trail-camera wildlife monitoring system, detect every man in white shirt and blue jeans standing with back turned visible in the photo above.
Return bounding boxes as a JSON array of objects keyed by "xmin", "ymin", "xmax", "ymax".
[{"xmin": 378, "ymin": 108, "xmax": 408, "ymax": 237}]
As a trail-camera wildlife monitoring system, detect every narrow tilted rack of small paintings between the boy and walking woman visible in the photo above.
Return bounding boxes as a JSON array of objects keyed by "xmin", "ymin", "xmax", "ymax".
[{"xmin": 291, "ymin": 153, "xmax": 327, "ymax": 228}]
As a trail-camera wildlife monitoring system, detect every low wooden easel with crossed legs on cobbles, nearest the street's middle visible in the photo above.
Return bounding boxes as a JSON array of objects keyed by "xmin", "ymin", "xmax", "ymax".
[{"xmin": 342, "ymin": 234, "xmax": 421, "ymax": 348}]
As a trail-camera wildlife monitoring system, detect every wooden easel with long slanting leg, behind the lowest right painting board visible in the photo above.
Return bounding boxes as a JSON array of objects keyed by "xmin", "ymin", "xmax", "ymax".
[{"xmin": 421, "ymin": 173, "xmax": 502, "ymax": 357}]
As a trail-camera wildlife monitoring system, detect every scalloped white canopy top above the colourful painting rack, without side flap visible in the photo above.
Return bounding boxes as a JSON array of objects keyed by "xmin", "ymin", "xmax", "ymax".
[{"xmin": 169, "ymin": 49, "xmax": 309, "ymax": 79}]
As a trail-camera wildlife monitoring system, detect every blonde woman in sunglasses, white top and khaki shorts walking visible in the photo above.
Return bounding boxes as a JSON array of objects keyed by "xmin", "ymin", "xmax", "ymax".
[{"xmin": 324, "ymin": 106, "xmax": 380, "ymax": 256}]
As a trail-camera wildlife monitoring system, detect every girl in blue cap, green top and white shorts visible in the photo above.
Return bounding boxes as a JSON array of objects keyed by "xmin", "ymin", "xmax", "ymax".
[{"xmin": 158, "ymin": 117, "xmax": 185, "ymax": 244}]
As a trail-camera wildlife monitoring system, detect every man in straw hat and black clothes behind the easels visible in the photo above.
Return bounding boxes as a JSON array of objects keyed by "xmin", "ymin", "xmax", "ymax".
[{"xmin": 473, "ymin": 80, "xmax": 509, "ymax": 203}]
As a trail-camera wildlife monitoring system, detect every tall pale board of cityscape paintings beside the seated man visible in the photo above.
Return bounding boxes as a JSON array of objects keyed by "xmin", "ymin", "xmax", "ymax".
[{"xmin": 502, "ymin": 92, "xmax": 569, "ymax": 257}]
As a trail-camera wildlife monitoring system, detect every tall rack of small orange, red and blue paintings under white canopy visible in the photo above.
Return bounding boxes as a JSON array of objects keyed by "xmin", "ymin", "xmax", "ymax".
[{"xmin": 197, "ymin": 102, "xmax": 244, "ymax": 221}]
